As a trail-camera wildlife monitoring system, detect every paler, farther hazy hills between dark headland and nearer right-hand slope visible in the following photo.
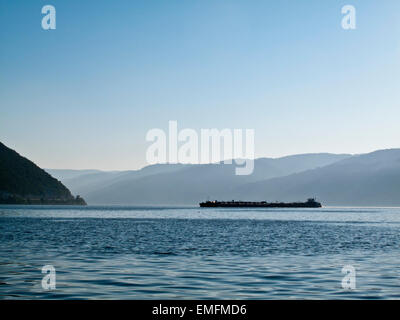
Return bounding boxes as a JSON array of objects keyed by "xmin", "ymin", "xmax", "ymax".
[{"xmin": 48, "ymin": 153, "xmax": 351, "ymax": 205}]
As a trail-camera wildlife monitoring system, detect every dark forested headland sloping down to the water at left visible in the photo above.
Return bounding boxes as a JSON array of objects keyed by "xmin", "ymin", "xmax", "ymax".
[{"xmin": 0, "ymin": 142, "xmax": 86, "ymax": 205}]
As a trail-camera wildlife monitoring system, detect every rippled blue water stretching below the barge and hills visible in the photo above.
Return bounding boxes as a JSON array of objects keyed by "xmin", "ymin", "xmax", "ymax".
[{"xmin": 0, "ymin": 206, "xmax": 400, "ymax": 299}]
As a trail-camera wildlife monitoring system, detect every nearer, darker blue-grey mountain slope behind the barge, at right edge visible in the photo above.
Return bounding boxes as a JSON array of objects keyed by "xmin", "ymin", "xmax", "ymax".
[{"xmin": 232, "ymin": 149, "xmax": 400, "ymax": 206}]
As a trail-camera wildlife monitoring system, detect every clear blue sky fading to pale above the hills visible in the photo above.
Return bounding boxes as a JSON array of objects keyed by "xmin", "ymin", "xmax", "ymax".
[{"xmin": 0, "ymin": 0, "xmax": 400, "ymax": 170}]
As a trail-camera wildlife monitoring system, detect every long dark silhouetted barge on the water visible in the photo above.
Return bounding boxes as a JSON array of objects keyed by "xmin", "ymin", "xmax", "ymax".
[{"xmin": 200, "ymin": 198, "xmax": 322, "ymax": 208}]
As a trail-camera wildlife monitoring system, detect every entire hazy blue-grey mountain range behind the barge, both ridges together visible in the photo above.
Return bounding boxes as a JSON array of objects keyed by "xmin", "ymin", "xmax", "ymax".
[{"xmin": 47, "ymin": 149, "xmax": 400, "ymax": 206}]
